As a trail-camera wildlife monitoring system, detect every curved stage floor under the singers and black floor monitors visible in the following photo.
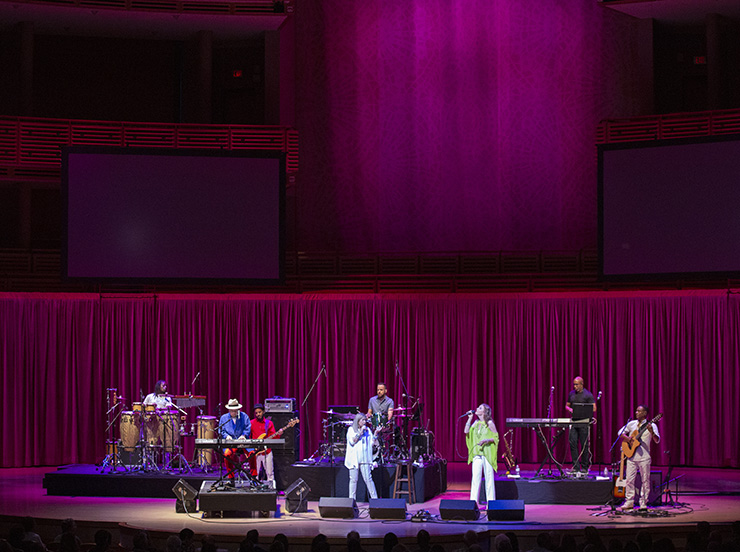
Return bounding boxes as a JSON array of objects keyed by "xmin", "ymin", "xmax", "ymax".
[{"xmin": 0, "ymin": 463, "xmax": 740, "ymax": 552}]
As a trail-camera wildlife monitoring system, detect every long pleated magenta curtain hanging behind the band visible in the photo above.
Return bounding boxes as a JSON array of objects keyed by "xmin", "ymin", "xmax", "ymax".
[{"xmin": 0, "ymin": 291, "xmax": 740, "ymax": 467}]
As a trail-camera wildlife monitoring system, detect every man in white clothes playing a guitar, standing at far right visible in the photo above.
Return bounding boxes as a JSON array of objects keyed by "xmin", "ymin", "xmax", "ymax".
[{"xmin": 619, "ymin": 404, "xmax": 660, "ymax": 511}]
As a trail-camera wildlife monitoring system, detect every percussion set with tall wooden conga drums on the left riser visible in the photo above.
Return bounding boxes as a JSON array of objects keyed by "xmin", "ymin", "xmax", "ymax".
[{"xmin": 98, "ymin": 388, "xmax": 212, "ymax": 473}]
